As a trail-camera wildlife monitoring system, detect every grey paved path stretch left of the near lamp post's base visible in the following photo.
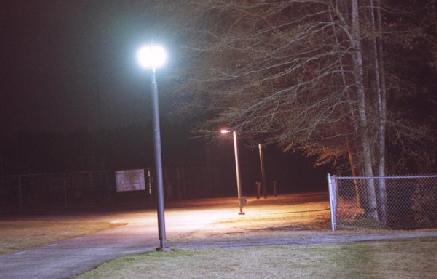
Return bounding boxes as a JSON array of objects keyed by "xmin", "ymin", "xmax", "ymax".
[{"xmin": 0, "ymin": 219, "xmax": 157, "ymax": 279}]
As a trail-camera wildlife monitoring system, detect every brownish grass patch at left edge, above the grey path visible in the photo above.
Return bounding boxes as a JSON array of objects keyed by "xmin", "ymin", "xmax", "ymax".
[{"xmin": 0, "ymin": 217, "xmax": 119, "ymax": 255}]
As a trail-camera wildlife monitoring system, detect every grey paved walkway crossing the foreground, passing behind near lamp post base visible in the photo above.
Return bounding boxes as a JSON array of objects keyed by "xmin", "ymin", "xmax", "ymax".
[{"xmin": 0, "ymin": 225, "xmax": 437, "ymax": 279}]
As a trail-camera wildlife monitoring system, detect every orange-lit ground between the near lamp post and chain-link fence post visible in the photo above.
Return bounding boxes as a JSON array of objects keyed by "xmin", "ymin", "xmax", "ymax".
[{"xmin": 144, "ymin": 193, "xmax": 329, "ymax": 240}]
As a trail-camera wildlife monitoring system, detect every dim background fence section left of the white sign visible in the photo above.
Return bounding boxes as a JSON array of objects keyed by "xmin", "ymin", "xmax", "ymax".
[{"xmin": 0, "ymin": 171, "xmax": 114, "ymax": 211}]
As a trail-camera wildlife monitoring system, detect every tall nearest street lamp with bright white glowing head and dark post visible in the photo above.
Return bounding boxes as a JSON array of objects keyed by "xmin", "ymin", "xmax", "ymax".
[{"xmin": 137, "ymin": 44, "xmax": 167, "ymax": 251}]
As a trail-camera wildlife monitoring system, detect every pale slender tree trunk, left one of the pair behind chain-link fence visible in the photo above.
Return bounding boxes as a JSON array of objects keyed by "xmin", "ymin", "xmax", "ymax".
[{"xmin": 351, "ymin": 0, "xmax": 379, "ymax": 221}]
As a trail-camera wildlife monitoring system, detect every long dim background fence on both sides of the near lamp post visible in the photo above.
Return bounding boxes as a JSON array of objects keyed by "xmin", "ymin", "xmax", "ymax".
[{"xmin": 0, "ymin": 167, "xmax": 228, "ymax": 211}]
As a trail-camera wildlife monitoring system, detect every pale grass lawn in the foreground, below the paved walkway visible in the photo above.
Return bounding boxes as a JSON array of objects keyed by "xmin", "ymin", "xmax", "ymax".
[{"xmin": 76, "ymin": 239, "xmax": 437, "ymax": 279}]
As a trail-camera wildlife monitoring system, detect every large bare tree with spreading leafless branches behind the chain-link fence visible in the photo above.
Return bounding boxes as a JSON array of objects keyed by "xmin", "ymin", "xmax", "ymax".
[{"xmin": 147, "ymin": 0, "xmax": 431, "ymax": 222}]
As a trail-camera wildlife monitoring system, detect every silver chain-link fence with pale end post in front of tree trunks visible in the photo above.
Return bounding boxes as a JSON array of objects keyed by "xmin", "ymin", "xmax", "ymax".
[{"xmin": 328, "ymin": 175, "xmax": 437, "ymax": 230}]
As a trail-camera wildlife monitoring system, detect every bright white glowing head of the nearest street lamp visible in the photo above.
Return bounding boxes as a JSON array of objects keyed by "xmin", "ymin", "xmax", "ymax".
[{"xmin": 137, "ymin": 45, "xmax": 167, "ymax": 70}]
